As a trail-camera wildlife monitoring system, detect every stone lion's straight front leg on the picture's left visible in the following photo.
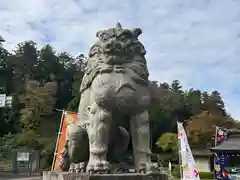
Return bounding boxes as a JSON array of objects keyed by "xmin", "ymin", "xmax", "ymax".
[{"xmin": 87, "ymin": 103, "xmax": 112, "ymax": 172}]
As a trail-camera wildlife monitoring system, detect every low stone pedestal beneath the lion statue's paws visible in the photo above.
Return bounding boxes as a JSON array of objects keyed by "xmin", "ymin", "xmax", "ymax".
[{"xmin": 43, "ymin": 172, "xmax": 168, "ymax": 180}]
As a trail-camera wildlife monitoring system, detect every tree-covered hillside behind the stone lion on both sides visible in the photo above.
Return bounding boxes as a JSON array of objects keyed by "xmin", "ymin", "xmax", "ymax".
[{"xmin": 0, "ymin": 41, "xmax": 239, "ymax": 167}]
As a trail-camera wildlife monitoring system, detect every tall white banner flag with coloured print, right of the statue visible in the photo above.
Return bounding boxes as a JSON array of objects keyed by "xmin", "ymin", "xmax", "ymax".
[{"xmin": 177, "ymin": 123, "xmax": 200, "ymax": 180}]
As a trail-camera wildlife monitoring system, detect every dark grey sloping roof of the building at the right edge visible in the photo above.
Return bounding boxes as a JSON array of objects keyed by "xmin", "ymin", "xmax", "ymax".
[{"xmin": 210, "ymin": 131, "xmax": 240, "ymax": 152}]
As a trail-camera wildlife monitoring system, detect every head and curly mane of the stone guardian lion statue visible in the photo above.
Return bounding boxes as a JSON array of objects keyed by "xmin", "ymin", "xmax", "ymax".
[{"xmin": 80, "ymin": 23, "xmax": 149, "ymax": 92}]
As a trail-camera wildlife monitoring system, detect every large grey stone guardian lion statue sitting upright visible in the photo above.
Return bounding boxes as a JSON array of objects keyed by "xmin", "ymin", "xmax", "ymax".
[{"xmin": 62, "ymin": 23, "xmax": 151, "ymax": 173}]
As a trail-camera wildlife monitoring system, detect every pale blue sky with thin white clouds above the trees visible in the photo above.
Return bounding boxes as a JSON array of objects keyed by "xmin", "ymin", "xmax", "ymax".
[{"xmin": 0, "ymin": 0, "xmax": 240, "ymax": 120}]
